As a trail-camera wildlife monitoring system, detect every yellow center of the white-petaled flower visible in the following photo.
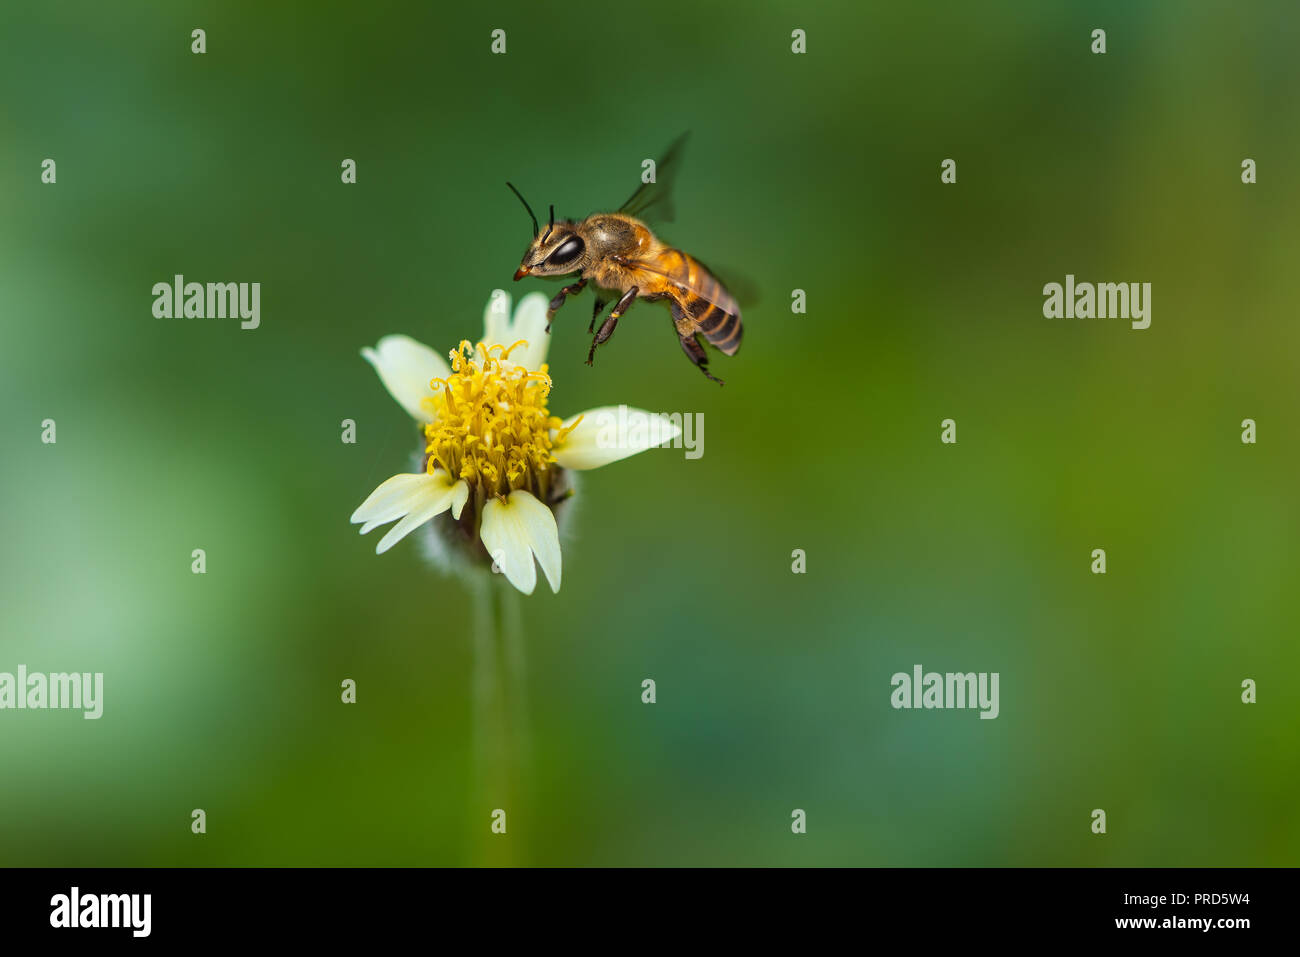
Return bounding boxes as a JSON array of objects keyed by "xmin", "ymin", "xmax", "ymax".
[{"xmin": 424, "ymin": 341, "xmax": 576, "ymax": 502}]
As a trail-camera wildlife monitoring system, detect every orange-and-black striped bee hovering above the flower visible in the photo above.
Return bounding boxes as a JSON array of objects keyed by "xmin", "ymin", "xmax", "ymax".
[{"xmin": 506, "ymin": 134, "xmax": 744, "ymax": 385}]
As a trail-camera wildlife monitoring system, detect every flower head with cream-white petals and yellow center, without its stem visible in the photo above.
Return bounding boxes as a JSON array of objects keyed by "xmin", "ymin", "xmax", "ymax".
[{"xmin": 352, "ymin": 290, "xmax": 681, "ymax": 594}]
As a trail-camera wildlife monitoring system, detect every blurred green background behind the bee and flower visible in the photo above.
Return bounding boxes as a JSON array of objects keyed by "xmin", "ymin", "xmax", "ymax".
[{"xmin": 0, "ymin": 0, "xmax": 1300, "ymax": 866}]
